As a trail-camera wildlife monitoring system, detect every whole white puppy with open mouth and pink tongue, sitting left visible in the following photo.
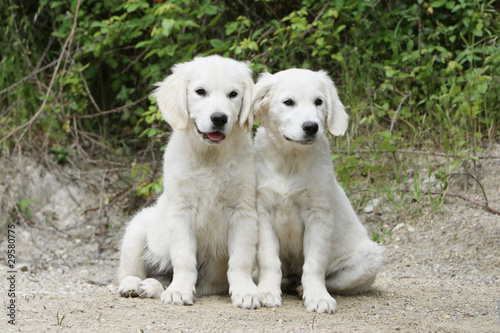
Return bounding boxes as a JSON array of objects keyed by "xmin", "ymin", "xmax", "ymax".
[{"xmin": 118, "ymin": 56, "xmax": 260, "ymax": 308}]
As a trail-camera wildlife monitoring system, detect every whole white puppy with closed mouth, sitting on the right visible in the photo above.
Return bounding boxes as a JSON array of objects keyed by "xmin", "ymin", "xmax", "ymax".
[{"xmin": 253, "ymin": 69, "xmax": 383, "ymax": 313}]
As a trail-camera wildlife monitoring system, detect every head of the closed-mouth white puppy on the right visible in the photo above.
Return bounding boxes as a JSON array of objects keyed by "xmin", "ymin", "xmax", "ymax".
[{"xmin": 252, "ymin": 69, "xmax": 348, "ymax": 144}]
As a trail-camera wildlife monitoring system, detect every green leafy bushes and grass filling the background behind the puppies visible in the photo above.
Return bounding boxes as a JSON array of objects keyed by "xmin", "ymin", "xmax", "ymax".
[{"xmin": 0, "ymin": 0, "xmax": 500, "ymax": 215}]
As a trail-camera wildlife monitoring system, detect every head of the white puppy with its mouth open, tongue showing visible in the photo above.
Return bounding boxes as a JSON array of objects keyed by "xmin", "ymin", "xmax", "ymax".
[{"xmin": 153, "ymin": 55, "xmax": 254, "ymax": 144}]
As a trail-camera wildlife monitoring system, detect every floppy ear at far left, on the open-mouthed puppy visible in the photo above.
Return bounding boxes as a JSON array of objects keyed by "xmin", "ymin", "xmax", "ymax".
[{"xmin": 153, "ymin": 63, "xmax": 189, "ymax": 131}]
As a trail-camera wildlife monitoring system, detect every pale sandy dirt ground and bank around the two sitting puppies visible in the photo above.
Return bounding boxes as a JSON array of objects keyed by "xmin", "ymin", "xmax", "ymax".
[{"xmin": 0, "ymin": 145, "xmax": 500, "ymax": 332}]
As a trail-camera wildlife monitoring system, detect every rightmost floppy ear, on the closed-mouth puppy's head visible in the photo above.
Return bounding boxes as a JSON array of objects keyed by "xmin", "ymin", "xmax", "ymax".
[{"xmin": 318, "ymin": 71, "xmax": 349, "ymax": 135}]
